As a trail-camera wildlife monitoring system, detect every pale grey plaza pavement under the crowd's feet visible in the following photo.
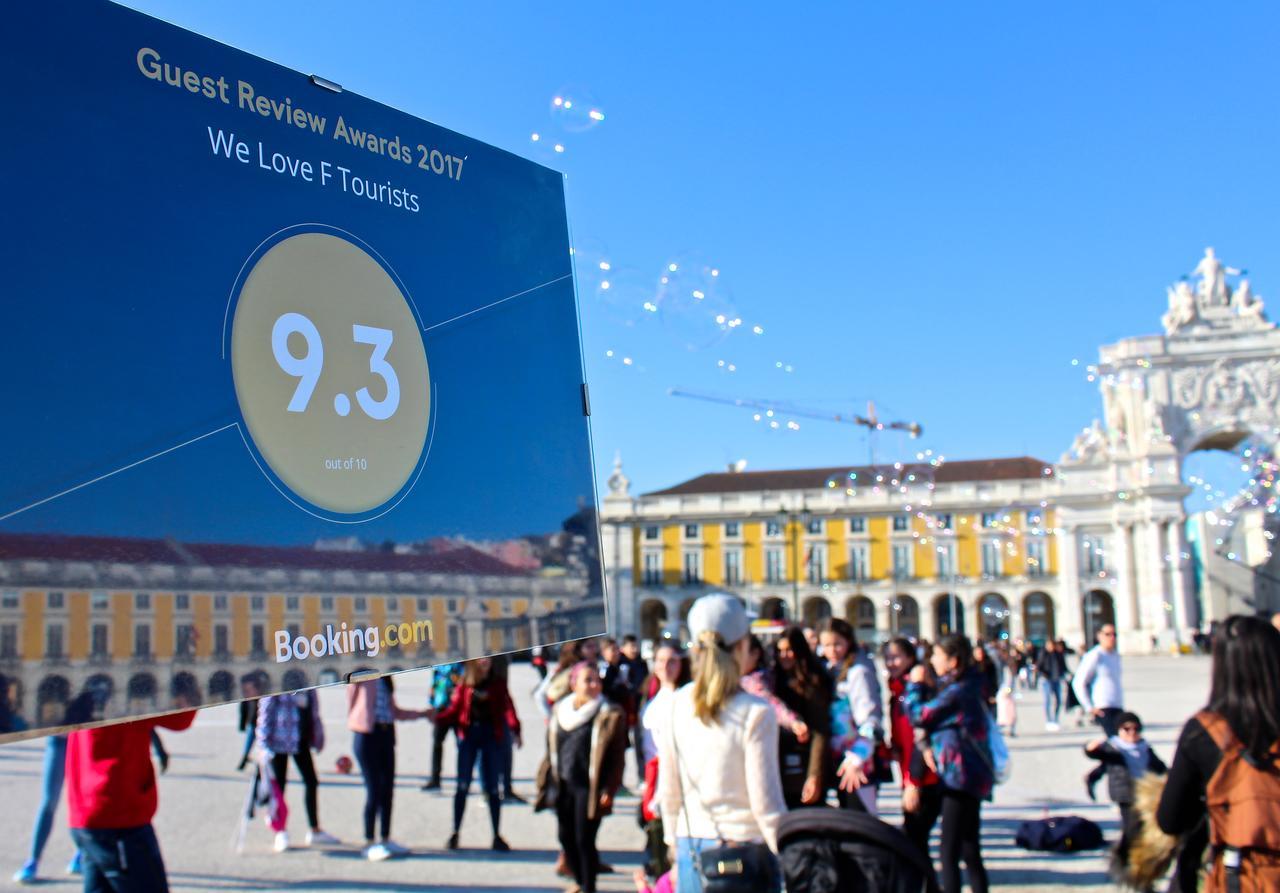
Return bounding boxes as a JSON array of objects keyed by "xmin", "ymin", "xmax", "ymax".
[{"xmin": 0, "ymin": 656, "xmax": 1210, "ymax": 893}]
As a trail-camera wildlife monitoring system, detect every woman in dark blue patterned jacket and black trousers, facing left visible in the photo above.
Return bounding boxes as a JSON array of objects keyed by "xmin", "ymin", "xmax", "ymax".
[{"xmin": 905, "ymin": 633, "xmax": 996, "ymax": 893}]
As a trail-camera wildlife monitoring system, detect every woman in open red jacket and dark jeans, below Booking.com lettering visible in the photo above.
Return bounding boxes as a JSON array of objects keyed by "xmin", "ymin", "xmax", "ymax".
[{"xmin": 435, "ymin": 658, "xmax": 524, "ymax": 852}]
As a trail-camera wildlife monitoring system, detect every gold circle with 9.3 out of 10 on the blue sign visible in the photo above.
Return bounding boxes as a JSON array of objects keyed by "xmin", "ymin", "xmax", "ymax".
[{"xmin": 232, "ymin": 233, "xmax": 431, "ymax": 514}]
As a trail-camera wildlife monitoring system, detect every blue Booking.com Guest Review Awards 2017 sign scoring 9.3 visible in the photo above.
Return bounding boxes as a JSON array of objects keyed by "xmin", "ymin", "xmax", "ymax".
[{"xmin": 0, "ymin": 3, "xmax": 605, "ymax": 739}]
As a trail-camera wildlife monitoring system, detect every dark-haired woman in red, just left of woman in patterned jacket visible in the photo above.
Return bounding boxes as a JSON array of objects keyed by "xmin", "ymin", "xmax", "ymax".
[{"xmin": 884, "ymin": 638, "xmax": 942, "ymax": 866}]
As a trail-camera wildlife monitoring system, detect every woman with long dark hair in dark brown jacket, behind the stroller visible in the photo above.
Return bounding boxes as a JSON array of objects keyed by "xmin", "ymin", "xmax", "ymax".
[{"xmin": 773, "ymin": 627, "xmax": 832, "ymax": 810}]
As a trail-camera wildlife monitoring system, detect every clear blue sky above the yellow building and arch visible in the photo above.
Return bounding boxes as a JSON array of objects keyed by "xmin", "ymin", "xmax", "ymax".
[{"xmin": 120, "ymin": 0, "xmax": 1280, "ymax": 490}]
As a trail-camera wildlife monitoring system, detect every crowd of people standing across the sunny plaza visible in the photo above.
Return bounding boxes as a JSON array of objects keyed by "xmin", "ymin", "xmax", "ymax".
[{"xmin": 14, "ymin": 606, "xmax": 1280, "ymax": 893}]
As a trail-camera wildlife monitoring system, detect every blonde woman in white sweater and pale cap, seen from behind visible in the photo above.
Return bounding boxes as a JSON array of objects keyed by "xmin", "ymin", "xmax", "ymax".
[{"xmin": 658, "ymin": 595, "xmax": 786, "ymax": 893}]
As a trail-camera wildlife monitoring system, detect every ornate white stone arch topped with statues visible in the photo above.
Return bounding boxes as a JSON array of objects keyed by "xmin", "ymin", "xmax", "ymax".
[{"xmin": 1056, "ymin": 248, "xmax": 1280, "ymax": 651}]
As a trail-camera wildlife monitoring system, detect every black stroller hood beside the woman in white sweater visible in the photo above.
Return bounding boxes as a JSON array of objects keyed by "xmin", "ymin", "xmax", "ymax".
[{"xmin": 778, "ymin": 807, "xmax": 938, "ymax": 893}]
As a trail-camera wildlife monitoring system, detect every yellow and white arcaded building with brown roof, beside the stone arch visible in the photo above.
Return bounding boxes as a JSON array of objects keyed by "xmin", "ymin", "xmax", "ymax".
[{"xmin": 602, "ymin": 457, "xmax": 1111, "ymax": 644}]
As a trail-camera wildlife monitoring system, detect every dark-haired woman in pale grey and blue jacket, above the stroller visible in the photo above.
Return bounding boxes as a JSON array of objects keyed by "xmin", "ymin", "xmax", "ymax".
[{"xmin": 818, "ymin": 617, "xmax": 884, "ymax": 815}]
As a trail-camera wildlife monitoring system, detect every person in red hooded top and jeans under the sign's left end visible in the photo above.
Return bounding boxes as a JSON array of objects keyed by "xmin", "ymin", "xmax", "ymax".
[{"xmin": 67, "ymin": 710, "xmax": 196, "ymax": 893}]
